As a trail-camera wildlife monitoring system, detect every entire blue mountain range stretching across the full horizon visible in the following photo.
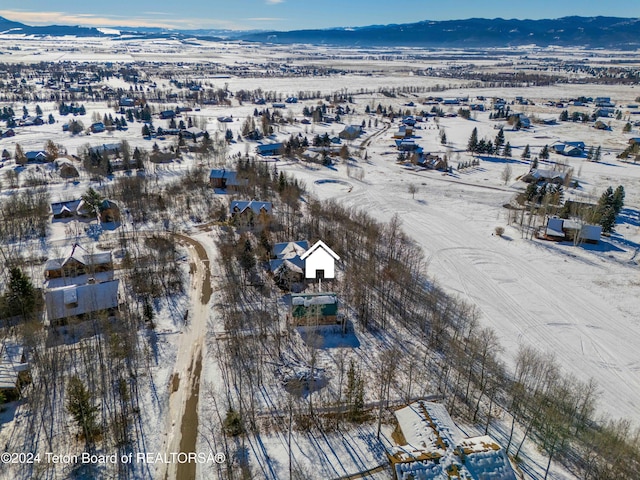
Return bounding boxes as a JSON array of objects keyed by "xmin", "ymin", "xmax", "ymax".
[{"xmin": 0, "ymin": 16, "xmax": 640, "ymax": 49}]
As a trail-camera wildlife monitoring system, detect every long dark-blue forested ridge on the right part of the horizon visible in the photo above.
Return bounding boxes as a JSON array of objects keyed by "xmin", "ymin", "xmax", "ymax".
[{"xmin": 241, "ymin": 17, "xmax": 640, "ymax": 49}]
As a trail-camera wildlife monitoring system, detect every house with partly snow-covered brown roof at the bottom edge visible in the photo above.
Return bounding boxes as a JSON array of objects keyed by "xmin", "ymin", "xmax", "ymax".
[{"xmin": 388, "ymin": 400, "xmax": 517, "ymax": 480}]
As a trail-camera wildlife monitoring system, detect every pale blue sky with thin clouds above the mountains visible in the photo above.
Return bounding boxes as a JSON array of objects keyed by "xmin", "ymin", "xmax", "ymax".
[{"xmin": 0, "ymin": 0, "xmax": 640, "ymax": 30}]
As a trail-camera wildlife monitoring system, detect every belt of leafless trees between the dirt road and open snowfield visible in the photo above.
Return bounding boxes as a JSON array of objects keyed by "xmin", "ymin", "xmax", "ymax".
[{"xmin": 206, "ymin": 160, "xmax": 640, "ymax": 480}]
